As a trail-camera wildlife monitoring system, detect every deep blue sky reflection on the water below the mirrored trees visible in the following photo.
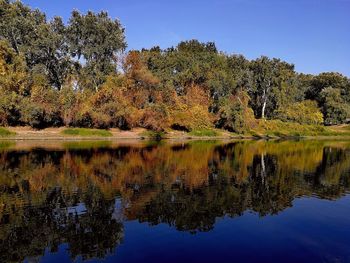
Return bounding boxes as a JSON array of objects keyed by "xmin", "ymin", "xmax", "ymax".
[{"xmin": 36, "ymin": 196, "xmax": 350, "ymax": 263}]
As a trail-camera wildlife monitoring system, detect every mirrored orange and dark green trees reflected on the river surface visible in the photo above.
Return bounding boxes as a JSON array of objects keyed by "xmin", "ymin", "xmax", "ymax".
[{"xmin": 0, "ymin": 141, "xmax": 350, "ymax": 262}]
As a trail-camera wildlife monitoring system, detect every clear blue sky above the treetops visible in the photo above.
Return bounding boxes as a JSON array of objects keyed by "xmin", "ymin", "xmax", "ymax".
[{"xmin": 23, "ymin": 0, "xmax": 350, "ymax": 77}]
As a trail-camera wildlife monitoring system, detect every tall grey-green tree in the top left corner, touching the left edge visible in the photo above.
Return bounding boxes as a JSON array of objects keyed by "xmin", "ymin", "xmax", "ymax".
[{"xmin": 0, "ymin": 0, "xmax": 72, "ymax": 89}]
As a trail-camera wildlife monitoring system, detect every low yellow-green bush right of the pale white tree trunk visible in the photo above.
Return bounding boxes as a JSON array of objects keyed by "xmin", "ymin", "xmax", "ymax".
[{"xmin": 276, "ymin": 100, "xmax": 323, "ymax": 125}]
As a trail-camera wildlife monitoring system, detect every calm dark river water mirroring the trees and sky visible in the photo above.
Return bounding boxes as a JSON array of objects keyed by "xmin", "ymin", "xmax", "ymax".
[{"xmin": 0, "ymin": 141, "xmax": 350, "ymax": 263}]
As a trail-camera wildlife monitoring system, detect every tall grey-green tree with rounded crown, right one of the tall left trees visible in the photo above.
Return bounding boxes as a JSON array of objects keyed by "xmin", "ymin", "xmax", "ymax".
[{"xmin": 67, "ymin": 11, "xmax": 126, "ymax": 90}]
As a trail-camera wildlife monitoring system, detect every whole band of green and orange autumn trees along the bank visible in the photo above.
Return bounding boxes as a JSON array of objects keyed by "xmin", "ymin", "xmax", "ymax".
[{"xmin": 0, "ymin": 0, "xmax": 350, "ymax": 134}]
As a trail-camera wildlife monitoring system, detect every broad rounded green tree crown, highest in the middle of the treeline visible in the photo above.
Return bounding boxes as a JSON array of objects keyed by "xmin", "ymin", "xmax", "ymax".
[{"xmin": 142, "ymin": 40, "xmax": 221, "ymax": 95}]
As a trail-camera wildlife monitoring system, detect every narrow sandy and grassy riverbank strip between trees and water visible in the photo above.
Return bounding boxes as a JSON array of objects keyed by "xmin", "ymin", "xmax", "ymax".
[{"xmin": 0, "ymin": 123, "xmax": 350, "ymax": 140}]
